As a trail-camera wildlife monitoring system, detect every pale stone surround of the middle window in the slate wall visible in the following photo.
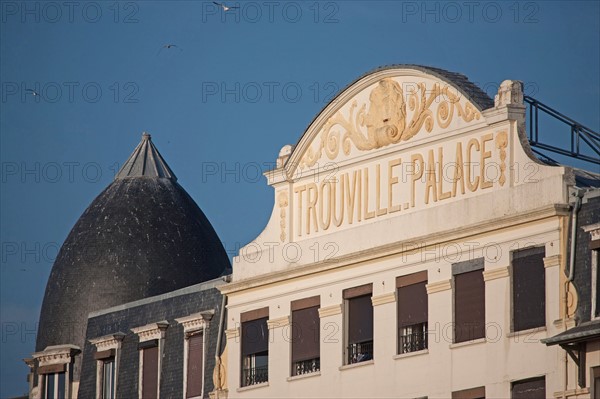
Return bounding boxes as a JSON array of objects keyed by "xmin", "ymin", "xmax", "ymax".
[{"xmin": 131, "ymin": 320, "xmax": 169, "ymax": 399}]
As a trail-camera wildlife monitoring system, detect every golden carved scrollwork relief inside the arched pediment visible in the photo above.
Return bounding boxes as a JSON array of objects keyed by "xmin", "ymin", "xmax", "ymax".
[{"xmin": 300, "ymin": 78, "xmax": 481, "ymax": 168}]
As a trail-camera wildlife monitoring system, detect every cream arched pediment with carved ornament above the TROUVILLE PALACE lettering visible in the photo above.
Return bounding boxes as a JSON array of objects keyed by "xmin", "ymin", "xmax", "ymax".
[{"xmin": 286, "ymin": 65, "xmax": 493, "ymax": 176}]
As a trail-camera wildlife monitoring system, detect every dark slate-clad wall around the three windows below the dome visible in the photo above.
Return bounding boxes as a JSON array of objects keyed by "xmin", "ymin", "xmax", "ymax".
[{"xmin": 79, "ymin": 279, "xmax": 222, "ymax": 399}]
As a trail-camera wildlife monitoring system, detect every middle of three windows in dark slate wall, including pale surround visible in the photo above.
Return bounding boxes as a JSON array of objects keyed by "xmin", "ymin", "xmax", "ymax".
[{"xmin": 131, "ymin": 321, "xmax": 169, "ymax": 399}]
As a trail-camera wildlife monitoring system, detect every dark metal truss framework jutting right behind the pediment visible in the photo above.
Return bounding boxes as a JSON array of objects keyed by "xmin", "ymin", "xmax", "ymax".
[{"xmin": 523, "ymin": 96, "xmax": 600, "ymax": 165}]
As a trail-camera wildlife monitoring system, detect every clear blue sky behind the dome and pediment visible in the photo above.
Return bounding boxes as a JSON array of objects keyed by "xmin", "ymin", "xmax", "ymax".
[{"xmin": 0, "ymin": 0, "xmax": 600, "ymax": 398}]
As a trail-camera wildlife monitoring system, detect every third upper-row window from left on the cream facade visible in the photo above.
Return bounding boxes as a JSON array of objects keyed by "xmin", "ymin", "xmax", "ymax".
[{"xmin": 344, "ymin": 284, "xmax": 373, "ymax": 364}]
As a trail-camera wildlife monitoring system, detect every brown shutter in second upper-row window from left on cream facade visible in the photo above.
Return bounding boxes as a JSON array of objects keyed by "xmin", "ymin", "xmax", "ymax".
[{"xmin": 291, "ymin": 306, "xmax": 320, "ymax": 362}]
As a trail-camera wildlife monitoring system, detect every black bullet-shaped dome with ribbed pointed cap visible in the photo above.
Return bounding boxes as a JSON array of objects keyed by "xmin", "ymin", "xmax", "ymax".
[{"xmin": 36, "ymin": 134, "xmax": 231, "ymax": 351}]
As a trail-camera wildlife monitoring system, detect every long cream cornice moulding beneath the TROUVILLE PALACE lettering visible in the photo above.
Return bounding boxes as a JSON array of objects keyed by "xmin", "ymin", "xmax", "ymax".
[{"xmin": 223, "ymin": 204, "xmax": 569, "ymax": 295}]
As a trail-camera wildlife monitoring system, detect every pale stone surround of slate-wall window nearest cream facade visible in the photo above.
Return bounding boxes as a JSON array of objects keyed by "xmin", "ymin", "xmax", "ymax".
[{"xmin": 175, "ymin": 309, "xmax": 215, "ymax": 399}]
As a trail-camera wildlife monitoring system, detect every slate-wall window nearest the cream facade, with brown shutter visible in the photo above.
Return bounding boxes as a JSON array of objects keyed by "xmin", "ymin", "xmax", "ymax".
[{"xmin": 175, "ymin": 310, "xmax": 214, "ymax": 398}]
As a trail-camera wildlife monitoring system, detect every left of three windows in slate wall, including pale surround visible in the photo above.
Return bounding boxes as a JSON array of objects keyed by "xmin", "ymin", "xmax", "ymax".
[{"xmin": 90, "ymin": 332, "xmax": 125, "ymax": 399}]
